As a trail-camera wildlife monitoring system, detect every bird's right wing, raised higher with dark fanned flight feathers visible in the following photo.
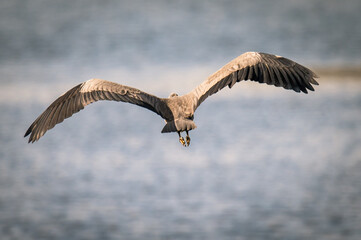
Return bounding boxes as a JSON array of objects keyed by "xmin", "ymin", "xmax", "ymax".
[{"xmin": 187, "ymin": 52, "xmax": 318, "ymax": 111}]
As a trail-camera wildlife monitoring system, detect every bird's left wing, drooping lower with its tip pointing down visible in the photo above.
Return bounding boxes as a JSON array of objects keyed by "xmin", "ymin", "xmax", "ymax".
[{"xmin": 24, "ymin": 79, "xmax": 162, "ymax": 143}]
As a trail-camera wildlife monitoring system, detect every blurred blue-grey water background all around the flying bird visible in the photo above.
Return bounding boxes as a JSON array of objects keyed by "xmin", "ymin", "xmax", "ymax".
[{"xmin": 0, "ymin": 0, "xmax": 361, "ymax": 240}]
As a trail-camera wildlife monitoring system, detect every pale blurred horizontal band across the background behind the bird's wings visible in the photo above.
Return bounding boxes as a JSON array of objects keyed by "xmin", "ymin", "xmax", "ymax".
[{"xmin": 0, "ymin": 62, "xmax": 361, "ymax": 105}]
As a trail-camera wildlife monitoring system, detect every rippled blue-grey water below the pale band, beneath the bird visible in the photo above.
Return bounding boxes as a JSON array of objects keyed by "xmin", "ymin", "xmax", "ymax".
[{"xmin": 0, "ymin": 76, "xmax": 361, "ymax": 239}]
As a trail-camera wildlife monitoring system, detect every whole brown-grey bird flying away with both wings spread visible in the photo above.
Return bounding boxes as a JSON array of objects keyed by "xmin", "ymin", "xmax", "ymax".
[{"xmin": 24, "ymin": 52, "xmax": 318, "ymax": 146}]
